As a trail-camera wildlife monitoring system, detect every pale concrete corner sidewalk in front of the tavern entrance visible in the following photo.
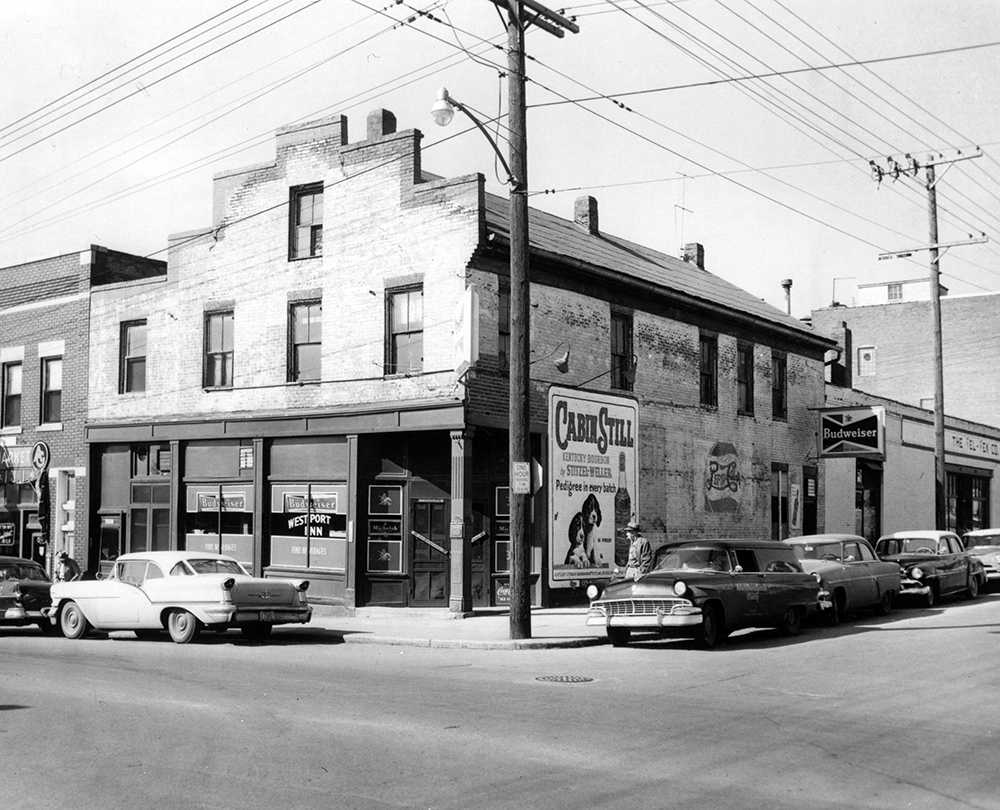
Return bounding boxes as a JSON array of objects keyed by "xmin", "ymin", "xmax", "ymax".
[{"xmin": 309, "ymin": 605, "xmax": 607, "ymax": 650}]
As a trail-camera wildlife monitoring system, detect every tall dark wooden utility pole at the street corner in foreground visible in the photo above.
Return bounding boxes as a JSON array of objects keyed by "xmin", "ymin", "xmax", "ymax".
[{"xmin": 490, "ymin": 0, "xmax": 580, "ymax": 639}]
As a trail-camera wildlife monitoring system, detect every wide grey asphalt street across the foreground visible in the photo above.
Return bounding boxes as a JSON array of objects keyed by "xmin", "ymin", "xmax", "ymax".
[{"xmin": 0, "ymin": 595, "xmax": 1000, "ymax": 810}]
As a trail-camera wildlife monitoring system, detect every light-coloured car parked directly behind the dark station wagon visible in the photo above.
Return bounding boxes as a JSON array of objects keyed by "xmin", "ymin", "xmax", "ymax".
[{"xmin": 785, "ymin": 534, "xmax": 900, "ymax": 624}]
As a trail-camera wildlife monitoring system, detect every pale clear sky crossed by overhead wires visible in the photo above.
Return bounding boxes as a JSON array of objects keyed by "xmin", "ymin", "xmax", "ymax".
[{"xmin": 0, "ymin": 0, "xmax": 1000, "ymax": 317}]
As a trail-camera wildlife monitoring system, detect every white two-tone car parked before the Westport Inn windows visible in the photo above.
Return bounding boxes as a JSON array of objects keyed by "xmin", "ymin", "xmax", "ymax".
[{"xmin": 45, "ymin": 551, "xmax": 312, "ymax": 644}]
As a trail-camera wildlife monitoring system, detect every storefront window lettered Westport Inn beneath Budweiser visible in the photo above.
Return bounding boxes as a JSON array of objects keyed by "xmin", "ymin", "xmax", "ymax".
[{"xmin": 271, "ymin": 484, "xmax": 347, "ymax": 571}]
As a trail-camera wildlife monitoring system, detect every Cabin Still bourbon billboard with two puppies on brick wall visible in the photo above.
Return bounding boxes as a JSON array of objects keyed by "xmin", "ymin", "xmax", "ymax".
[{"xmin": 548, "ymin": 386, "xmax": 639, "ymax": 588}]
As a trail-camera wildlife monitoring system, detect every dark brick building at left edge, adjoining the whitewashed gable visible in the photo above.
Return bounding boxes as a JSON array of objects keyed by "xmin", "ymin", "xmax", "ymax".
[{"xmin": 0, "ymin": 245, "xmax": 166, "ymax": 565}]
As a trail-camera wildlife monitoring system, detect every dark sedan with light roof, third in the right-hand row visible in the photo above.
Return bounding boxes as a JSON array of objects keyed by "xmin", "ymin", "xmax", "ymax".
[{"xmin": 875, "ymin": 530, "xmax": 986, "ymax": 607}]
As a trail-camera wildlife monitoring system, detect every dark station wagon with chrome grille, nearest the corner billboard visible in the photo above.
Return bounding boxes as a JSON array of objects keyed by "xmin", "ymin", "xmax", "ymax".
[{"xmin": 587, "ymin": 539, "xmax": 830, "ymax": 648}]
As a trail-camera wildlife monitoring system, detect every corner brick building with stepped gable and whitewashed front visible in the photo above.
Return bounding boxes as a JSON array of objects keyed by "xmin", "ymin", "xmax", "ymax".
[{"xmin": 87, "ymin": 110, "xmax": 834, "ymax": 611}]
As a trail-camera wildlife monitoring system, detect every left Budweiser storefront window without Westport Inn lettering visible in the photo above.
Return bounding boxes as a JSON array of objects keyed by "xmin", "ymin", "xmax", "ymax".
[{"xmin": 185, "ymin": 484, "xmax": 254, "ymax": 570}]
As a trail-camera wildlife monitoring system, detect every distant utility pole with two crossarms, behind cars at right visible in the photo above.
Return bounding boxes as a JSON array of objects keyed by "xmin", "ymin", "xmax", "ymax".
[{"xmin": 869, "ymin": 149, "xmax": 987, "ymax": 531}]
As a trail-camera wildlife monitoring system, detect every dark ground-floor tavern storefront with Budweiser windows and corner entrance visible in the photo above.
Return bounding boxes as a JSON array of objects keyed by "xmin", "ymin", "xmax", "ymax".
[{"xmin": 88, "ymin": 407, "xmax": 543, "ymax": 611}]
